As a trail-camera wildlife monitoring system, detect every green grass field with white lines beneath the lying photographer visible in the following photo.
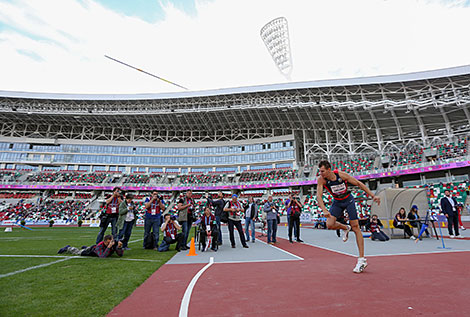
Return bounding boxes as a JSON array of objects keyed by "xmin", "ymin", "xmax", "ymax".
[{"xmin": 0, "ymin": 227, "xmax": 180, "ymax": 316}]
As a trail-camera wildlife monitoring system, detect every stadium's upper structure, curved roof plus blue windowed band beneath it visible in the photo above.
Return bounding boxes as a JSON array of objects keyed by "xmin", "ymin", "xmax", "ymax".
[{"xmin": 0, "ymin": 66, "xmax": 470, "ymax": 188}]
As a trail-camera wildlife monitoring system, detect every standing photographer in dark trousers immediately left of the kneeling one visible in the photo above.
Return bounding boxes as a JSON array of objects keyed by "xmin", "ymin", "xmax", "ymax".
[{"xmin": 143, "ymin": 191, "xmax": 165, "ymax": 250}]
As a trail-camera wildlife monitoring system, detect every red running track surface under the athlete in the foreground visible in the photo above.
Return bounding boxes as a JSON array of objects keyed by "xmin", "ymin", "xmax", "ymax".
[{"xmin": 110, "ymin": 239, "xmax": 470, "ymax": 317}]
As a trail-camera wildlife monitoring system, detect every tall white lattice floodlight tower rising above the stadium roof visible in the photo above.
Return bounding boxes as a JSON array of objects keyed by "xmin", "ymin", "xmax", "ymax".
[{"xmin": 260, "ymin": 17, "xmax": 293, "ymax": 80}]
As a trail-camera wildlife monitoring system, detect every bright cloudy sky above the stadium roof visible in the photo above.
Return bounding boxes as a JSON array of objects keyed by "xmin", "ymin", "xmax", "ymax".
[{"xmin": 0, "ymin": 0, "xmax": 470, "ymax": 93}]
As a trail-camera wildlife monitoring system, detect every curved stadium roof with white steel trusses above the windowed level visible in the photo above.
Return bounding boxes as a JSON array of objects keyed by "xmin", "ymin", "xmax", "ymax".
[{"xmin": 0, "ymin": 66, "xmax": 470, "ymax": 154}]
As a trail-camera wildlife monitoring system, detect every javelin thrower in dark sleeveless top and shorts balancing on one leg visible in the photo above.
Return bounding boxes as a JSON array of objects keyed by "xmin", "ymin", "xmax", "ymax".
[{"xmin": 317, "ymin": 161, "xmax": 380, "ymax": 273}]
